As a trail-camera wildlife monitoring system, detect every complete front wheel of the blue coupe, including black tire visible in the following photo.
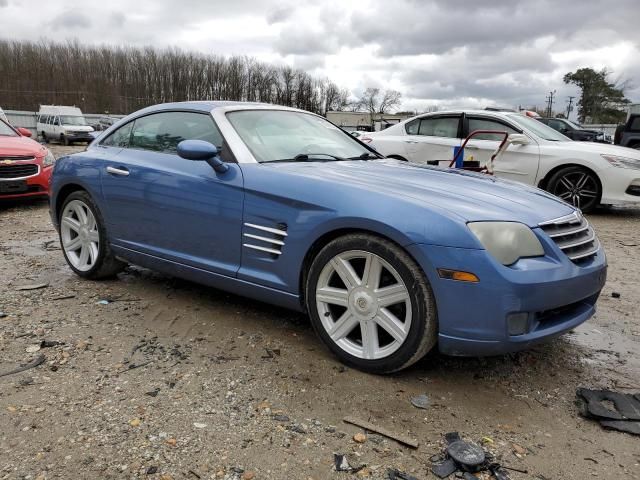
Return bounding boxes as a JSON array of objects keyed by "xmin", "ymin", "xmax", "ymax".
[{"xmin": 305, "ymin": 234, "xmax": 438, "ymax": 373}]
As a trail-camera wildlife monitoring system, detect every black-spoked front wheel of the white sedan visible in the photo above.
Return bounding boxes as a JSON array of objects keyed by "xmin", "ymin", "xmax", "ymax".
[{"xmin": 546, "ymin": 166, "xmax": 602, "ymax": 213}]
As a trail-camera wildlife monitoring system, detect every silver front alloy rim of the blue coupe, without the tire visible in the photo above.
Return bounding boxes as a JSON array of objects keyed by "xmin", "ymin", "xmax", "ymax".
[{"xmin": 316, "ymin": 250, "xmax": 412, "ymax": 360}]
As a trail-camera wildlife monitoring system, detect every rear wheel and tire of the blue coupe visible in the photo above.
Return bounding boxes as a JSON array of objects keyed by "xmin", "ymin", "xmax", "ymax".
[{"xmin": 58, "ymin": 191, "xmax": 125, "ymax": 280}]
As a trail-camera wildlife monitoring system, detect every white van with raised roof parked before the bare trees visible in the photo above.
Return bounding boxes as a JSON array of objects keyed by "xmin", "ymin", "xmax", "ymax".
[{"xmin": 37, "ymin": 105, "xmax": 93, "ymax": 145}]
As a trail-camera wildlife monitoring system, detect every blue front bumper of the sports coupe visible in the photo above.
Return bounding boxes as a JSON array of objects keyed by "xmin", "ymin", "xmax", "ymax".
[{"xmin": 409, "ymin": 235, "xmax": 607, "ymax": 356}]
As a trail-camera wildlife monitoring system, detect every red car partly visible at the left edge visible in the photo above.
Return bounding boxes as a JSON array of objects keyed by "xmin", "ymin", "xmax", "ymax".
[{"xmin": 0, "ymin": 119, "xmax": 55, "ymax": 200}]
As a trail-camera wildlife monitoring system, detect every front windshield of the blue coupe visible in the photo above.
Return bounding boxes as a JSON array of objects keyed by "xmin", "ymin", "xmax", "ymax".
[{"xmin": 227, "ymin": 110, "xmax": 377, "ymax": 162}]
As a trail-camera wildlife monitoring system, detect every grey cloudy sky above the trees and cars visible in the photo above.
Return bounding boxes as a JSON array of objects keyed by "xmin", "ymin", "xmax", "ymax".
[{"xmin": 0, "ymin": 0, "xmax": 640, "ymax": 115}]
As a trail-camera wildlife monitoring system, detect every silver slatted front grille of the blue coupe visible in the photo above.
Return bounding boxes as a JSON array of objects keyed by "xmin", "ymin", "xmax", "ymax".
[{"xmin": 540, "ymin": 211, "xmax": 600, "ymax": 263}]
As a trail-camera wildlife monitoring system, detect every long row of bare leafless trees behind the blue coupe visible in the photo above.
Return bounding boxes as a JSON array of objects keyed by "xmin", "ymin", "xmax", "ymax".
[{"xmin": 0, "ymin": 40, "xmax": 352, "ymax": 115}]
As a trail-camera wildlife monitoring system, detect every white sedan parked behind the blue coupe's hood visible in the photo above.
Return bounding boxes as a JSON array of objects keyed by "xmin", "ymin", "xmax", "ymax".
[{"xmin": 360, "ymin": 110, "xmax": 640, "ymax": 212}]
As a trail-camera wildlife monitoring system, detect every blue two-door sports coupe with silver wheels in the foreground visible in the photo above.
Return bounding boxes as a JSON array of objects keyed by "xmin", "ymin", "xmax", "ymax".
[{"xmin": 51, "ymin": 102, "xmax": 606, "ymax": 373}]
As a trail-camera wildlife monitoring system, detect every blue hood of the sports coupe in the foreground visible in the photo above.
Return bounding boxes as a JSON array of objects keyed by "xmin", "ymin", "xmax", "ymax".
[{"xmin": 267, "ymin": 160, "xmax": 575, "ymax": 227}]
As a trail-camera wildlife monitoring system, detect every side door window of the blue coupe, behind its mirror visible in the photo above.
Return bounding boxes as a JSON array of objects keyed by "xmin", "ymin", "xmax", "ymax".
[{"xmin": 129, "ymin": 112, "xmax": 223, "ymax": 153}]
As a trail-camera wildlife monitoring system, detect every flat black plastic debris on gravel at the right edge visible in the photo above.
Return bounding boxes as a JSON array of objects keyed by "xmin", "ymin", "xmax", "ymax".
[{"xmin": 576, "ymin": 388, "xmax": 640, "ymax": 435}]
